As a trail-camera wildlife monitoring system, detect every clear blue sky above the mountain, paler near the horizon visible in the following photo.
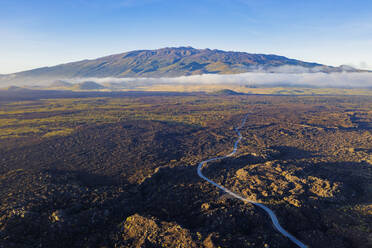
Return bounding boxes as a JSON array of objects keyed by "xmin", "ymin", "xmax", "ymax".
[{"xmin": 0, "ymin": 0, "xmax": 372, "ymax": 74}]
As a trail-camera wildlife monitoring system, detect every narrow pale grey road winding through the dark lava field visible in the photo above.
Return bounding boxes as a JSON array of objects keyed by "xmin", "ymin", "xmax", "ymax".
[{"xmin": 197, "ymin": 114, "xmax": 307, "ymax": 248}]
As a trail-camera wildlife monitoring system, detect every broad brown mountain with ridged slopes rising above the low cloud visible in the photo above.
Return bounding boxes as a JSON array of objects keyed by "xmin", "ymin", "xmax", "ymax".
[{"xmin": 0, "ymin": 47, "xmax": 366, "ymax": 85}]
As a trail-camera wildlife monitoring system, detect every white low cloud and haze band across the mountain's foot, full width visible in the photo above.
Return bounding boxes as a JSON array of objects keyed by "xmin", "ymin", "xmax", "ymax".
[{"xmin": 0, "ymin": 66, "xmax": 372, "ymax": 89}]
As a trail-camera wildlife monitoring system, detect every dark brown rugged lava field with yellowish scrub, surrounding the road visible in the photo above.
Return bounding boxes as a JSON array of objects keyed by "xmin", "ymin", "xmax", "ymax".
[{"xmin": 0, "ymin": 92, "xmax": 372, "ymax": 248}]
